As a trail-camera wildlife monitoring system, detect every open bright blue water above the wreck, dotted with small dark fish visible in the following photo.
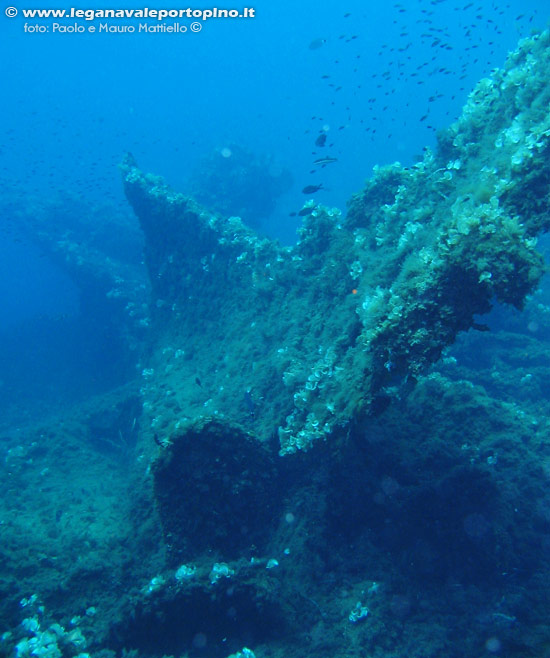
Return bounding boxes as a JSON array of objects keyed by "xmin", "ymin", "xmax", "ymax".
[{"xmin": 0, "ymin": 0, "xmax": 547, "ymax": 213}]
